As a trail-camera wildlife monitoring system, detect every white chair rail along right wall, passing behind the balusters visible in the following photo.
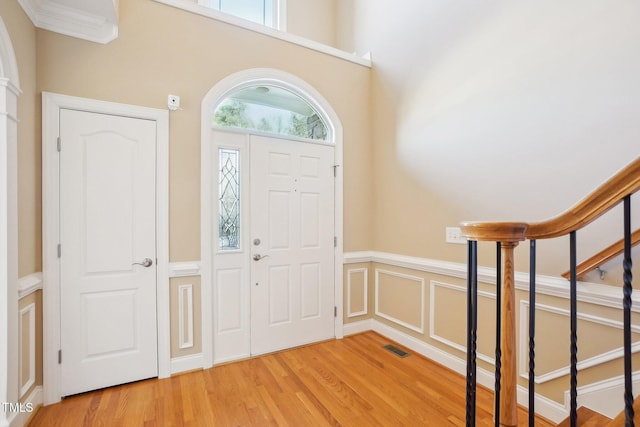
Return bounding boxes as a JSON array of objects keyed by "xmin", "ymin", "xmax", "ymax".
[{"xmin": 344, "ymin": 251, "xmax": 640, "ymax": 313}]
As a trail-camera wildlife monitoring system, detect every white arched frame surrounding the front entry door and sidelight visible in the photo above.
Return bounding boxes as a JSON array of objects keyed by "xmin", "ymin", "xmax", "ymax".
[{"xmin": 200, "ymin": 68, "xmax": 344, "ymax": 368}]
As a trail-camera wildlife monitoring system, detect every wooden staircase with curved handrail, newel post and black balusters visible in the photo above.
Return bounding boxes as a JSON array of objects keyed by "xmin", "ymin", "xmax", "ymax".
[{"xmin": 461, "ymin": 158, "xmax": 640, "ymax": 427}]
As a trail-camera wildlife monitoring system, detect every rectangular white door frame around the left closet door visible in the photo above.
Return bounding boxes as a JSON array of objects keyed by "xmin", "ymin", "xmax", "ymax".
[{"xmin": 42, "ymin": 92, "xmax": 171, "ymax": 405}]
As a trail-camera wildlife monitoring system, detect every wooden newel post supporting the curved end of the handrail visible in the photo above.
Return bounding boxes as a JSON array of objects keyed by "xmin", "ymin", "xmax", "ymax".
[{"xmin": 500, "ymin": 242, "xmax": 518, "ymax": 426}]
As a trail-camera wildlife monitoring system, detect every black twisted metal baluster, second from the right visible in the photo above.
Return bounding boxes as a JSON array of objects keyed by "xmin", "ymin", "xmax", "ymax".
[{"xmin": 569, "ymin": 231, "xmax": 578, "ymax": 427}]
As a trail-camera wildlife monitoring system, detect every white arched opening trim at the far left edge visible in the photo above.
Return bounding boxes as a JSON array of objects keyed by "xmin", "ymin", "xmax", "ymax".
[{"xmin": 0, "ymin": 17, "xmax": 21, "ymax": 426}]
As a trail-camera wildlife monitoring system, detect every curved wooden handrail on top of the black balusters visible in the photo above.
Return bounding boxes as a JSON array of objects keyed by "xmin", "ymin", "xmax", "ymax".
[{"xmin": 460, "ymin": 157, "xmax": 640, "ymax": 242}]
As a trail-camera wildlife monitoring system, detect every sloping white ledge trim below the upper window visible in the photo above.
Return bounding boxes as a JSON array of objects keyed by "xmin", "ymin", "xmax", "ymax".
[{"xmin": 154, "ymin": 0, "xmax": 371, "ymax": 68}]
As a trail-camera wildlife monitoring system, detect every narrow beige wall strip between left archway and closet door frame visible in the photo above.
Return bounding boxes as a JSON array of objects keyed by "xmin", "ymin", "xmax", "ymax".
[{"xmin": 0, "ymin": 0, "xmax": 42, "ymax": 277}]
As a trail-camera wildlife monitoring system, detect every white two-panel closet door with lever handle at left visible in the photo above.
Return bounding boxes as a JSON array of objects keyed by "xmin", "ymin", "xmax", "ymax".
[{"xmin": 59, "ymin": 109, "xmax": 158, "ymax": 396}]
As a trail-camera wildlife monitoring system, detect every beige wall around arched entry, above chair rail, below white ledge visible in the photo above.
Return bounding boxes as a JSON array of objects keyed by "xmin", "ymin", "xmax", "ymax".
[{"xmin": 37, "ymin": 0, "xmax": 371, "ymax": 261}]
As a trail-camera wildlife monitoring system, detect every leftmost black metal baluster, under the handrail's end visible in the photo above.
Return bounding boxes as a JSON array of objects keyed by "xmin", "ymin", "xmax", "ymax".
[{"xmin": 466, "ymin": 240, "xmax": 478, "ymax": 427}]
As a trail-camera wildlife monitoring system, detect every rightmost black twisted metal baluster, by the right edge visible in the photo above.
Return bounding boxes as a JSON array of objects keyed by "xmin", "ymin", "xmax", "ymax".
[{"xmin": 622, "ymin": 196, "xmax": 634, "ymax": 426}]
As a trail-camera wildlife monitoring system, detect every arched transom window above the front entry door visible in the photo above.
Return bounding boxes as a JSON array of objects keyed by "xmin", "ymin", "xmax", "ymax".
[{"xmin": 213, "ymin": 84, "xmax": 331, "ymax": 141}]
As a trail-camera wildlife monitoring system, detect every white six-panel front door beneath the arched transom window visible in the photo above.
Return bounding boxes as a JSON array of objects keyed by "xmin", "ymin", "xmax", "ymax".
[{"xmin": 250, "ymin": 136, "xmax": 334, "ymax": 355}]
